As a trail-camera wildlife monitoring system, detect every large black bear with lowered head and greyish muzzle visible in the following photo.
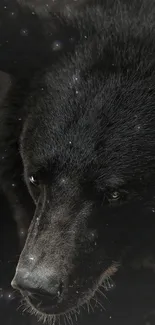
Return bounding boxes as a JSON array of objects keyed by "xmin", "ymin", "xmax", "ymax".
[{"xmin": 0, "ymin": 0, "xmax": 155, "ymax": 321}]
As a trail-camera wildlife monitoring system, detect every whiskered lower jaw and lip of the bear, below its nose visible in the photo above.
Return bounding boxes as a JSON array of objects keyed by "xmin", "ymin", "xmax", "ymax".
[{"xmin": 21, "ymin": 262, "xmax": 120, "ymax": 322}]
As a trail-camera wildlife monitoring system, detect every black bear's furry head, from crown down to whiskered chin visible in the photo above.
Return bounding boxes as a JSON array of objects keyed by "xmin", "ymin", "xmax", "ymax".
[{"xmin": 9, "ymin": 0, "xmax": 155, "ymax": 319}]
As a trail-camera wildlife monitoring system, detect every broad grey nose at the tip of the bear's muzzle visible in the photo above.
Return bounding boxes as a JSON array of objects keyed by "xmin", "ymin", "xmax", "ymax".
[{"xmin": 11, "ymin": 269, "xmax": 63, "ymax": 312}]
